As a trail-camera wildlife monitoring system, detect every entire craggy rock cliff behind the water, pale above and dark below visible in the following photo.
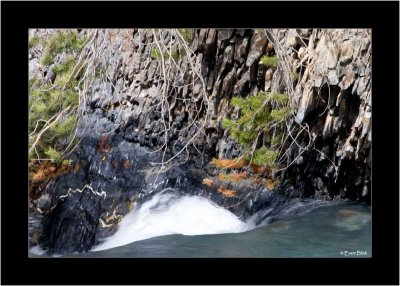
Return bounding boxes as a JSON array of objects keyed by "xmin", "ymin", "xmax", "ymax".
[{"xmin": 30, "ymin": 29, "xmax": 372, "ymax": 252}]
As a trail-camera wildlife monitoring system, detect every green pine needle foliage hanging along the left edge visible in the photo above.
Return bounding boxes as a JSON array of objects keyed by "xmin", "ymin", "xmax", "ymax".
[{"xmin": 28, "ymin": 30, "xmax": 87, "ymax": 164}]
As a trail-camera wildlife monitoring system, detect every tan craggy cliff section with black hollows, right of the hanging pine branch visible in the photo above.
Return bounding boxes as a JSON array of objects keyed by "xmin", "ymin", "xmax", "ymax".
[{"xmin": 266, "ymin": 29, "xmax": 372, "ymax": 202}]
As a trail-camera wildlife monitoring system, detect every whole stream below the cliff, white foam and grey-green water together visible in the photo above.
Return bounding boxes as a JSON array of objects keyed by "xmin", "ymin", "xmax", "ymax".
[{"xmin": 31, "ymin": 189, "xmax": 371, "ymax": 257}]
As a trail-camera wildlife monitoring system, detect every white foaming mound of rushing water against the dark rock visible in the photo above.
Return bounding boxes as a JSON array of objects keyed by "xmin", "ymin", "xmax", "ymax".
[{"xmin": 92, "ymin": 192, "xmax": 254, "ymax": 251}]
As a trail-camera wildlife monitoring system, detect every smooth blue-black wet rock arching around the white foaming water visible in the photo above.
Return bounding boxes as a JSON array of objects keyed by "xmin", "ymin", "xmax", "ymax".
[{"xmin": 30, "ymin": 135, "xmax": 285, "ymax": 255}]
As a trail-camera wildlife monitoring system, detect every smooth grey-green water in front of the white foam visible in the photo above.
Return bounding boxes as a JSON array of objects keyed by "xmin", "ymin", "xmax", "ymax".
[{"xmin": 65, "ymin": 204, "xmax": 372, "ymax": 258}]
